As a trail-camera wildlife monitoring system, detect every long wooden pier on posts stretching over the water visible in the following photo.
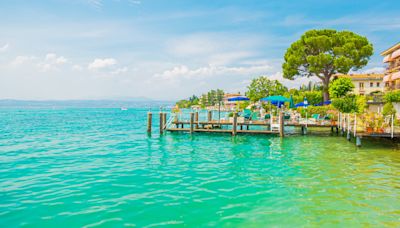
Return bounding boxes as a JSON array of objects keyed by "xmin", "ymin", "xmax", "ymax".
[{"xmin": 147, "ymin": 111, "xmax": 400, "ymax": 146}]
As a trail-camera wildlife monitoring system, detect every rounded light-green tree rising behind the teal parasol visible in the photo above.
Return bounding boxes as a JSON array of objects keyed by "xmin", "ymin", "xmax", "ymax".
[{"xmin": 246, "ymin": 76, "xmax": 288, "ymax": 102}]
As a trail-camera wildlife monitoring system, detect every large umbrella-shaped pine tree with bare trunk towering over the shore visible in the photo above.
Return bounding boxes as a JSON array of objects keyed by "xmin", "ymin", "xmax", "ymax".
[{"xmin": 282, "ymin": 29, "xmax": 373, "ymax": 101}]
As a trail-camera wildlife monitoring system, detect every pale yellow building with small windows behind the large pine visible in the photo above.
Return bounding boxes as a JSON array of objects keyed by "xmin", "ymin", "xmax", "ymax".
[{"xmin": 335, "ymin": 74, "xmax": 385, "ymax": 95}]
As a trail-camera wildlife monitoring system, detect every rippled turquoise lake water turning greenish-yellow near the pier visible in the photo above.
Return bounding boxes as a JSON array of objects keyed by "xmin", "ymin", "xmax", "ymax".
[{"xmin": 0, "ymin": 108, "xmax": 400, "ymax": 227}]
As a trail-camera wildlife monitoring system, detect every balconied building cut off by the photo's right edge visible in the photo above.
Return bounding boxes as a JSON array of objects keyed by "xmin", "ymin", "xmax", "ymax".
[{"xmin": 381, "ymin": 43, "xmax": 400, "ymax": 90}]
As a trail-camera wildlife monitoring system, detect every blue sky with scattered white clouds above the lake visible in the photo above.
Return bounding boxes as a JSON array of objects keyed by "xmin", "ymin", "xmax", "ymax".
[{"xmin": 0, "ymin": 0, "xmax": 400, "ymax": 100}]
